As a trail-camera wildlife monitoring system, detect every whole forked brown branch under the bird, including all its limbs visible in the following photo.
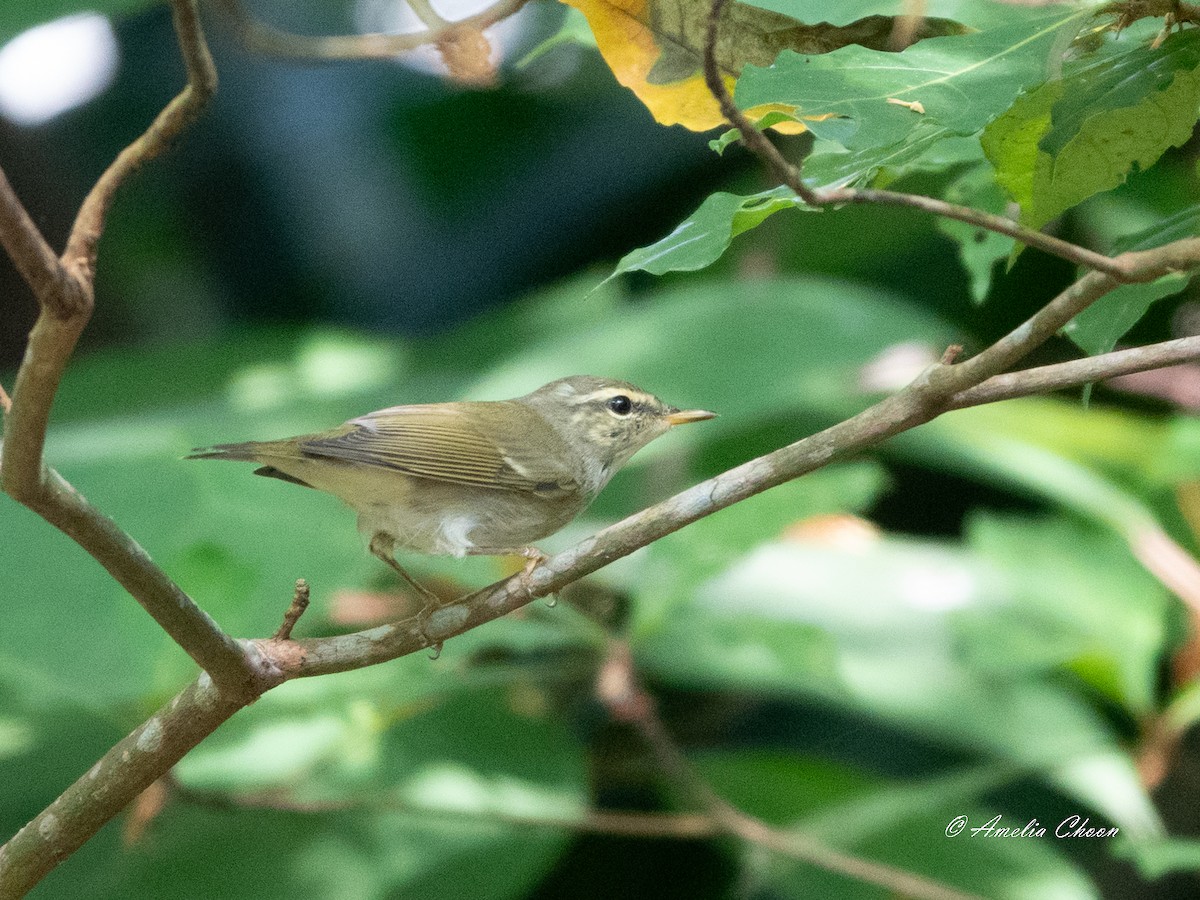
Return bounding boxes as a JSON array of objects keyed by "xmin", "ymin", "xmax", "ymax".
[{"xmin": 7, "ymin": 0, "xmax": 1200, "ymax": 898}]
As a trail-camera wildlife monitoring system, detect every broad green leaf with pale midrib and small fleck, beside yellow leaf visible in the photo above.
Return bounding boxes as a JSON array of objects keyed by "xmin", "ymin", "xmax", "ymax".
[{"xmin": 736, "ymin": 7, "xmax": 1088, "ymax": 149}]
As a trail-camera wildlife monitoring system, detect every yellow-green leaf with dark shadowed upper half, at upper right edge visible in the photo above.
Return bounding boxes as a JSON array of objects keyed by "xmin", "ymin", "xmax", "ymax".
[{"xmin": 984, "ymin": 29, "xmax": 1200, "ymax": 228}]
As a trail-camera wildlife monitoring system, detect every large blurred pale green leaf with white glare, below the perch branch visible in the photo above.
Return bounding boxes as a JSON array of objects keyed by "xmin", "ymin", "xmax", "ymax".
[{"xmin": 636, "ymin": 521, "xmax": 1165, "ymax": 834}]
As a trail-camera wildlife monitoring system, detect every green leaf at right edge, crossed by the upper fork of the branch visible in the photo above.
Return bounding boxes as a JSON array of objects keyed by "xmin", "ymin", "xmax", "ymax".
[{"xmin": 1063, "ymin": 205, "xmax": 1200, "ymax": 354}]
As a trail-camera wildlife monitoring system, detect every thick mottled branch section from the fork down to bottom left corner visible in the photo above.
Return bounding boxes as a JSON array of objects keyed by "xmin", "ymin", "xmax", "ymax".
[{"xmin": 0, "ymin": 674, "xmax": 244, "ymax": 900}]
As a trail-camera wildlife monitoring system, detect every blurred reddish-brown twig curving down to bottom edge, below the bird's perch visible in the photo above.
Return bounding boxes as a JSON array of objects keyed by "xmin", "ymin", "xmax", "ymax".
[{"xmin": 598, "ymin": 640, "xmax": 972, "ymax": 900}]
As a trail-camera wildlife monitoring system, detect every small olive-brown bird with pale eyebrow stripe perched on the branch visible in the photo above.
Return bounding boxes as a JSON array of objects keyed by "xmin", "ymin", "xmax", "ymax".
[{"xmin": 186, "ymin": 376, "xmax": 716, "ymax": 602}]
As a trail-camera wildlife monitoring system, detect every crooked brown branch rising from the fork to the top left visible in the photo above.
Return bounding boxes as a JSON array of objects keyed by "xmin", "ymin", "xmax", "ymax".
[{"xmin": 0, "ymin": 0, "xmax": 255, "ymax": 696}]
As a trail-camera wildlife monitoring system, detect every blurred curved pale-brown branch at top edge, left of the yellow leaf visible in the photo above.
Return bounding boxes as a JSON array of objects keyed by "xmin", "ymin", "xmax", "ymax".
[{"xmin": 216, "ymin": 0, "xmax": 528, "ymax": 60}]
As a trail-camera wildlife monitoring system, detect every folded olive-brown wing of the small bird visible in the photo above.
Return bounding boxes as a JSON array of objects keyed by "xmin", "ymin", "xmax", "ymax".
[{"xmin": 300, "ymin": 403, "xmax": 578, "ymax": 498}]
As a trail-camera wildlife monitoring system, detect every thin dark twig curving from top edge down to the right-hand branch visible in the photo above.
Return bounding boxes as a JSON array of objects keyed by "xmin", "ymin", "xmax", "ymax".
[{"xmin": 704, "ymin": 0, "xmax": 1126, "ymax": 281}]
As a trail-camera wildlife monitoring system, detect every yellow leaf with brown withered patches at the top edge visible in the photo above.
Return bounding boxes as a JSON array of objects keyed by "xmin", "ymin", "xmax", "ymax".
[{"xmin": 563, "ymin": 0, "xmax": 967, "ymax": 133}]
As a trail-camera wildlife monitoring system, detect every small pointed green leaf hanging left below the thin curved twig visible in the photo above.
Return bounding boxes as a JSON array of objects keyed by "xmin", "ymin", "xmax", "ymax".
[{"xmin": 608, "ymin": 185, "xmax": 804, "ymax": 278}]
